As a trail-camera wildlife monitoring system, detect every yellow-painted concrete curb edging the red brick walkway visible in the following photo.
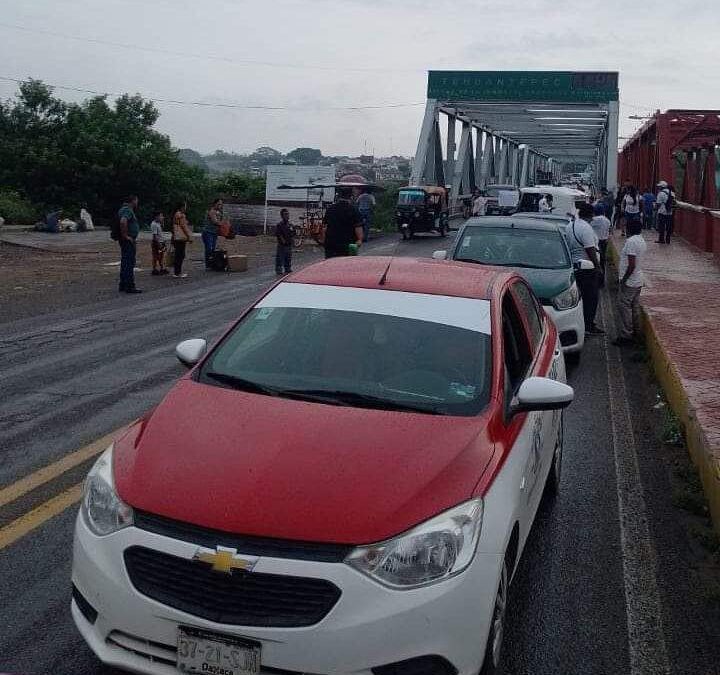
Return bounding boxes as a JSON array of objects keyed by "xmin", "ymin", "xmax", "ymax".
[{"xmin": 608, "ymin": 239, "xmax": 720, "ymax": 534}]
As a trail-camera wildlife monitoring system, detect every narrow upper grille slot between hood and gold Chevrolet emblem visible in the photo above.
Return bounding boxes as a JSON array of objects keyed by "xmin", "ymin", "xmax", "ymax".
[{"xmin": 135, "ymin": 511, "xmax": 352, "ymax": 562}]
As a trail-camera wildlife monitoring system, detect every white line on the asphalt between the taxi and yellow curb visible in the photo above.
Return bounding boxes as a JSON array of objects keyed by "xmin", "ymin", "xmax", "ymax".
[{"xmin": 602, "ymin": 290, "xmax": 670, "ymax": 675}]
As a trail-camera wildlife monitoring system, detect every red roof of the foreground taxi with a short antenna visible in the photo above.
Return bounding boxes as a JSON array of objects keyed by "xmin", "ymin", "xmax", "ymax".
[{"xmin": 283, "ymin": 256, "xmax": 516, "ymax": 300}]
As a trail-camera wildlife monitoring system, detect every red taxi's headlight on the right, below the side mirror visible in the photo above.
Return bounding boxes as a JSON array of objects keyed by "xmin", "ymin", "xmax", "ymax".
[{"xmin": 345, "ymin": 499, "xmax": 483, "ymax": 589}]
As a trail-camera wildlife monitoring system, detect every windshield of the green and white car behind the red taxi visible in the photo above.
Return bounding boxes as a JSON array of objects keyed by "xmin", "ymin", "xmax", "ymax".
[{"xmin": 455, "ymin": 227, "xmax": 570, "ymax": 269}]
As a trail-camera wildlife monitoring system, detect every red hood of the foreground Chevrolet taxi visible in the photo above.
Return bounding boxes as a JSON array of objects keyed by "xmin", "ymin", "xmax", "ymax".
[{"xmin": 113, "ymin": 378, "xmax": 493, "ymax": 544}]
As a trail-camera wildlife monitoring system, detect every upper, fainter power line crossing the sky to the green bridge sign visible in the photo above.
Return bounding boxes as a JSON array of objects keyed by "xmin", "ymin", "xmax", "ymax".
[{"xmin": 0, "ymin": 22, "xmax": 426, "ymax": 74}]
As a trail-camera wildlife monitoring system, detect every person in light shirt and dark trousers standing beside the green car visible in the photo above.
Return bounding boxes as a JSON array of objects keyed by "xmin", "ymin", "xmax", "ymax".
[{"xmin": 566, "ymin": 203, "xmax": 605, "ymax": 335}]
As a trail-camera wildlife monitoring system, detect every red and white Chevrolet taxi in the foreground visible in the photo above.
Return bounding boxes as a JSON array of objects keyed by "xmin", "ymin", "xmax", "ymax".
[{"xmin": 72, "ymin": 257, "xmax": 573, "ymax": 675}]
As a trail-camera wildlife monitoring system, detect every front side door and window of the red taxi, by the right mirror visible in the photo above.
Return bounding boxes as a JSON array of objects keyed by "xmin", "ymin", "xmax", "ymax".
[{"xmin": 502, "ymin": 287, "xmax": 542, "ymax": 549}]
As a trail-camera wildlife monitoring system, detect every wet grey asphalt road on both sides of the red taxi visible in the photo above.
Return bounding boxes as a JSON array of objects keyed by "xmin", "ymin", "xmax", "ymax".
[{"xmin": 0, "ymin": 230, "xmax": 720, "ymax": 675}]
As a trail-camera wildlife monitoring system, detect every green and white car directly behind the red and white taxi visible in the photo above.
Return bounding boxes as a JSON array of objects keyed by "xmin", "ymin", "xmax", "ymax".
[{"xmin": 437, "ymin": 215, "xmax": 585, "ymax": 354}]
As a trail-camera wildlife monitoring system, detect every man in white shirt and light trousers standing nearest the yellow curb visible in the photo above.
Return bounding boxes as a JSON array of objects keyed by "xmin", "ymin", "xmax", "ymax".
[{"xmin": 613, "ymin": 222, "xmax": 647, "ymax": 346}]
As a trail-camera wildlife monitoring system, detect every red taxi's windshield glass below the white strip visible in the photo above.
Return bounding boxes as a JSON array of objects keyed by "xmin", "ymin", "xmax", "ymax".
[{"xmin": 198, "ymin": 294, "xmax": 491, "ymax": 416}]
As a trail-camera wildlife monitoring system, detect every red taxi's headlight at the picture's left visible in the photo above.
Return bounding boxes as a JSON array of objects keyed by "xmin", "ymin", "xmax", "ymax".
[{"xmin": 82, "ymin": 445, "xmax": 133, "ymax": 537}]
